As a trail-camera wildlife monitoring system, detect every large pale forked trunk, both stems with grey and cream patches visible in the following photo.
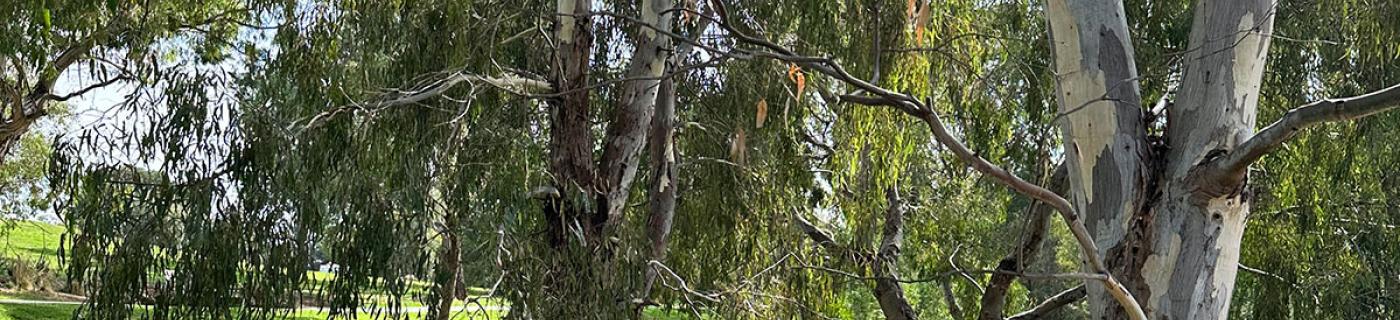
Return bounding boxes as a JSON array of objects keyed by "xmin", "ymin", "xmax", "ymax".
[{"xmin": 1047, "ymin": 0, "xmax": 1274, "ymax": 320}]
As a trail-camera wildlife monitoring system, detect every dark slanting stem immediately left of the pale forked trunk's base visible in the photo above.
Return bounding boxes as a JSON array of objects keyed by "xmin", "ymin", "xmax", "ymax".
[{"xmin": 979, "ymin": 165, "xmax": 1068, "ymax": 320}]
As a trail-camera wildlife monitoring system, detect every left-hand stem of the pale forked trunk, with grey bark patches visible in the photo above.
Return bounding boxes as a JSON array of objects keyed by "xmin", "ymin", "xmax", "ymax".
[{"xmin": 1047, "ymin": 0, "xmax": 1152, "ymax": 319}]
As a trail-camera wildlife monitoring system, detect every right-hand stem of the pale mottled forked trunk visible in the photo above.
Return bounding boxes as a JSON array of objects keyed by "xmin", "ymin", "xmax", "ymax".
[{"xmin": 1141, "ymin": 0, "xmax": 1275, "ymax": 320}]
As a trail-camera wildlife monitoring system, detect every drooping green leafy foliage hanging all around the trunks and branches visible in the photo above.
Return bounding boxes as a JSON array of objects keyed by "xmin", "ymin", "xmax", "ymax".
[{"xmin": 0, "ymin": 0, "xmax": 1400, "ymax": 319}]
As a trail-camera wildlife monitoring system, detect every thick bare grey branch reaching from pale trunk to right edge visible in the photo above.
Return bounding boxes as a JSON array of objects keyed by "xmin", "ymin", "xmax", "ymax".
[{"xmin": 1215, "ymin": 85, "xmax": 1400, "ymax": 183}]
